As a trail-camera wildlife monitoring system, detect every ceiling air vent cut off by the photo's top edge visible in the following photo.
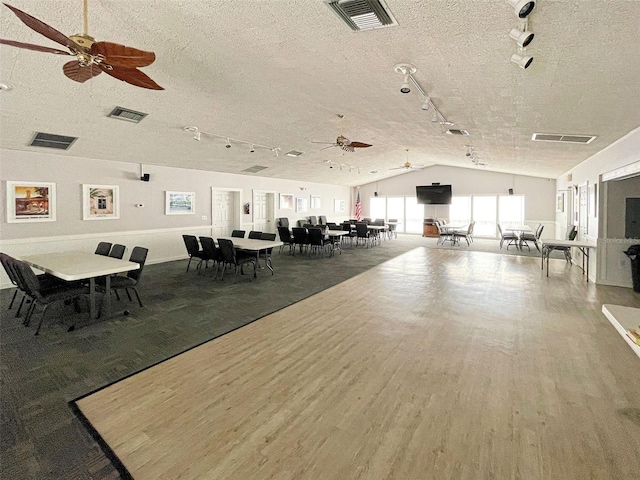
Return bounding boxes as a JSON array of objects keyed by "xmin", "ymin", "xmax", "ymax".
[{"xmin": 325, "ymin": 0, "xmax": 398, "ymax": 32}]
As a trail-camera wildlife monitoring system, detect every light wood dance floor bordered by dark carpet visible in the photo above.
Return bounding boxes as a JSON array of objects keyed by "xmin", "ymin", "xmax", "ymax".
[{"xmin": 78, "ymin": 248, "xmax": 640, "ymax": 480}]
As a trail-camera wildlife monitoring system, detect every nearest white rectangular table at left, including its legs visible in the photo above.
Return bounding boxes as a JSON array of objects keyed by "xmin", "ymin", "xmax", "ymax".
[{"xmin": 19, "ymin": 251, "xmax": 140, "ymax": 330}]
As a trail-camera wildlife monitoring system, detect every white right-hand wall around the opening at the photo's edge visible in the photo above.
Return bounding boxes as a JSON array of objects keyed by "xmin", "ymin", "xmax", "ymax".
[{"xmin": 556, "ymin": 127, "xmax": 640, "ymax": 287}]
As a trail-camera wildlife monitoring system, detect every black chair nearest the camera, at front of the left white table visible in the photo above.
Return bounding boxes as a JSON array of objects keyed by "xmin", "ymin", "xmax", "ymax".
[{"xmin": 10, "ymin": 259, "xmax": 88, "ymax": 335}]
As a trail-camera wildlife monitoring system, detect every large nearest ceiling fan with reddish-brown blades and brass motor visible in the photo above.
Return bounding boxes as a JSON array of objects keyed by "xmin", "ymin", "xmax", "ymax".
[{"xmin": 0, "ymin": 0, "xmax": 164, "ymax": 90}]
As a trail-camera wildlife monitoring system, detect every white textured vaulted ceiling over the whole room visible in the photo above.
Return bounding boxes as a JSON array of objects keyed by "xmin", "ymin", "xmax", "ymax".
[{"xmin": 0, "ymin": 0, "xmax": 640, "ymax": 186}]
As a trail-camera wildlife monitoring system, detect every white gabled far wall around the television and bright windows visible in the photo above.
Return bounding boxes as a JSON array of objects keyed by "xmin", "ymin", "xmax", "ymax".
[{"xmin": 360, "ymin": 165, "xmax": 556, "ymax": 238}]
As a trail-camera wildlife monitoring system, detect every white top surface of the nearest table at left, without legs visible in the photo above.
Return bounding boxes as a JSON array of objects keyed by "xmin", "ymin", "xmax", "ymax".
[{"xmin": 19, "ymin": 252, "xmax": 140, "ymax": 282}]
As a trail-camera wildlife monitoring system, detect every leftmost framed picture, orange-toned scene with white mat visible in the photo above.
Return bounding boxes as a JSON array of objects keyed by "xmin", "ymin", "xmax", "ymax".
[{"xmin": 7, "ymin": 181, "xmax": 56, "ymax": 223}]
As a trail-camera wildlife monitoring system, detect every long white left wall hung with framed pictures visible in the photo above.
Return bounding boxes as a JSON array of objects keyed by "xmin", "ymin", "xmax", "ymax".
[{"xmin": 0, "ymin": 149, "xmax": 351, "ymax": 287}]
